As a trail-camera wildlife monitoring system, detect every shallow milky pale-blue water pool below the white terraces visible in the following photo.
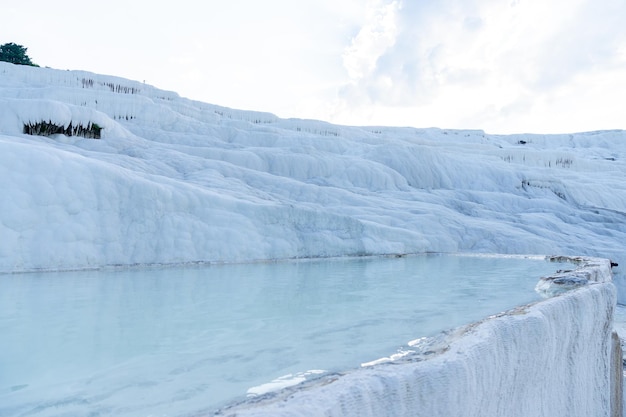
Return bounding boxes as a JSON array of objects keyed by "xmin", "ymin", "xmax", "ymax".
[{"xmin": 0, "ymin": 255, "xmax": 562, "ymax": 417}]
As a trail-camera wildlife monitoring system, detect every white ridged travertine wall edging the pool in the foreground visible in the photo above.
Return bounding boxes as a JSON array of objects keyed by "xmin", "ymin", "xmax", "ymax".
[{"xmin": 221, "ymin": 258, "xmax": 619, "ymax": 417}]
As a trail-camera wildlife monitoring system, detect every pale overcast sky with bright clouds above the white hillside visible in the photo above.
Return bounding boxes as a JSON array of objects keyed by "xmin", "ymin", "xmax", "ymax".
[{"xmin": 0, "ymin": 0, "xmax": 626, "ymax": 133}]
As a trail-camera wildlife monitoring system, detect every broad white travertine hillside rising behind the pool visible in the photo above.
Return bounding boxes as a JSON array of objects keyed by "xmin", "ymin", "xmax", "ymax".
[{"xmin": 0, "ymin": 63, "xmax": 626, "ymax": 288}]
